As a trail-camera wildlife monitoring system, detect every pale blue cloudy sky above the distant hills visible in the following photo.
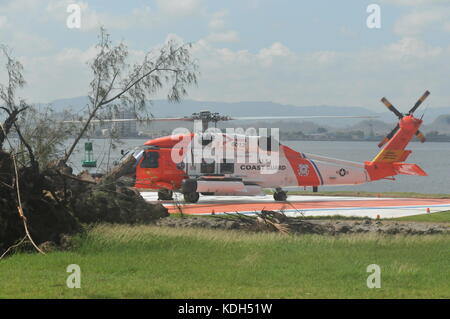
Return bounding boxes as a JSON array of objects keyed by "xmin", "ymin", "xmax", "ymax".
[{"xmin": 0, "ymin": 0, "xmax": 450, "ymax": 111}]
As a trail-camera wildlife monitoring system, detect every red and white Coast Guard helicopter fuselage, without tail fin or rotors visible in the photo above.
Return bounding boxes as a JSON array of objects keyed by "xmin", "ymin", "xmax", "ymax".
[{"xmin": 136, "ymin": 133, "xmax": 370, "ymax": 195}]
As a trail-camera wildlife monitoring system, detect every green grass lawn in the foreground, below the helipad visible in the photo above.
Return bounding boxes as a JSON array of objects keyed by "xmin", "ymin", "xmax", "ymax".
[{"xmin": 0, "ymin": 225, "xmax": 450, "ymax": 298}]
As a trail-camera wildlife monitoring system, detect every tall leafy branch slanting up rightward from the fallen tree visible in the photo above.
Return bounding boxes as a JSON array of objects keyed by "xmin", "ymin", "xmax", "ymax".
[{"xmin": 64, "ymin": 28, "xmax": 198, "ymax": 162}]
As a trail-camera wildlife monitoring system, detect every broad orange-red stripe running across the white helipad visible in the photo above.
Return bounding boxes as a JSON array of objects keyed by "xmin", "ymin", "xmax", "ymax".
[{"xmin": 163, "ymin": 198, "xmax": 450, "ymax": 214}]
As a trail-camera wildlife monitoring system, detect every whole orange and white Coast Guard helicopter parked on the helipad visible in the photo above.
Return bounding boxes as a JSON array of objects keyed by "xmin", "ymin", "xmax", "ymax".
[{"xmin": 122, "ymin": 91, "xmax": 430, "ymax": 203}]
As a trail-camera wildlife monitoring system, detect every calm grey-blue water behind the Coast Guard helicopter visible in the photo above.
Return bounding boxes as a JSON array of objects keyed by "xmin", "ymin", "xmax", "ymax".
[{"xmin": 70, "ymin": 139, "xmax": 450, "ymax": 193}]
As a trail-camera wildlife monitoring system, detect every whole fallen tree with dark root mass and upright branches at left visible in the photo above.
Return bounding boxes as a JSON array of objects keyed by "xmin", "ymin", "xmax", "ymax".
[{"xmin": 0, "ymin": 28, "xmax": 197, "ymax": 257}]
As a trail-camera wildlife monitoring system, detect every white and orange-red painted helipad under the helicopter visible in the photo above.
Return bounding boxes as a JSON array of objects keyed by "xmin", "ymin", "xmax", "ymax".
[{"xmin": 141, "ymin": 192, "xmax": 450, "ymax": 218}]
